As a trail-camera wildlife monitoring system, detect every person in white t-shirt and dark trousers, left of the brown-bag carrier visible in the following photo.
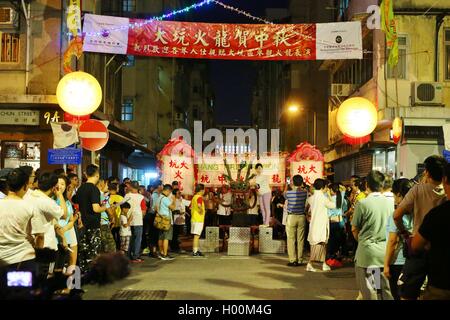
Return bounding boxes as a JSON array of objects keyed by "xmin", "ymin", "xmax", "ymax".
[{"xmin": 124, "ymin": 181, "xmax": 147, "ymax": 263}]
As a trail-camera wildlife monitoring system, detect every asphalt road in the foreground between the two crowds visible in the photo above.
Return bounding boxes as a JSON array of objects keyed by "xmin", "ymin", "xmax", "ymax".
[{"xmin": 83, "ymin": 253, "xmax": 358, "ymax": 300}]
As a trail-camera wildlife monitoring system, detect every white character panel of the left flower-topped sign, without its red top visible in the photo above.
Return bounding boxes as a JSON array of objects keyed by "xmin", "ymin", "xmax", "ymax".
[{"xmin": 162, "ymin": 156, "xmax": 195, "ymax": 195}]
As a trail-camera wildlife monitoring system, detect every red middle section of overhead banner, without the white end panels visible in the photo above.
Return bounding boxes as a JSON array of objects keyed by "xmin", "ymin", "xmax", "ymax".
[{"xmin": 128, "ymin": 19, "xmax": 316, "ymax": 60}]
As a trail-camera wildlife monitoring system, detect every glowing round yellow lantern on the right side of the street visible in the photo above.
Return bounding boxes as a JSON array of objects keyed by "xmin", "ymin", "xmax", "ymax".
[{"xmin": 336, "ymin": 97, "xmax": 378, "ymax": 138}]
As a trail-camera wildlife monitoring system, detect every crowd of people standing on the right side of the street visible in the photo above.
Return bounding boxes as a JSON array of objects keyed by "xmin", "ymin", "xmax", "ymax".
[{"xmin": 285, "ymin": 156, "xmax": 450, "ymax": 300}]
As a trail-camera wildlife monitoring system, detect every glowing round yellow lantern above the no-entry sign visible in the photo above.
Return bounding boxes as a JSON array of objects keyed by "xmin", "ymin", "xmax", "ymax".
[{"xmin": 56, "ymin": 71, "xmax": 102, "ymax": 116}]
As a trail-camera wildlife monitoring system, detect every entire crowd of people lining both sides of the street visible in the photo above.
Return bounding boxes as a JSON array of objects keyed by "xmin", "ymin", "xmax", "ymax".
[{"xmin": 0, "ymin": 156, "xmax": 450, "ymax": 299}]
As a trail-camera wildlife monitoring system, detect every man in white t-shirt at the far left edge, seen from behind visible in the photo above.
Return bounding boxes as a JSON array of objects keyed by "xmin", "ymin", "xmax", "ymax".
[{"xmin": 0, "ymin": 169, "xmax": 44, "ymax": 290}]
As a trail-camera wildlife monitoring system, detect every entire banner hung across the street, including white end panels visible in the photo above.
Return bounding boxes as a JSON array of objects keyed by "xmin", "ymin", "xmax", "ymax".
[{"xmin": 83, "ymin": 14, "xmax": 363, "ymax": 60}]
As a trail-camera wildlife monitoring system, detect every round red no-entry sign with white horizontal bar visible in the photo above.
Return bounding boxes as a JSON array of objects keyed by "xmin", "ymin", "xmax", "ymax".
[{"xmin": 79, "ymin": 119, "xmax": 109, "ymax": 151}]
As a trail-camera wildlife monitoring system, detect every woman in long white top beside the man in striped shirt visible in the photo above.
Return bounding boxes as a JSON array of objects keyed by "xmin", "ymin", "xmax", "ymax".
[{"xmin": 306, "ymin": 179, "xmax": 336, "ymax": 272}]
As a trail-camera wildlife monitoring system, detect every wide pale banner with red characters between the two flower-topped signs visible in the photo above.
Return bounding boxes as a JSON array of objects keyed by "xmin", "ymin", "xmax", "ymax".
[{"xmin": 198, "ymin": 155, "xmax": 286, "ymax": 187}]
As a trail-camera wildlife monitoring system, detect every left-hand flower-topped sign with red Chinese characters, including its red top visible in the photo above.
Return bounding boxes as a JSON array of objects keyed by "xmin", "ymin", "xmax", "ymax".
[{"xmin": 158, "ymin": 139, "xmax": 196, "ymax": 195}]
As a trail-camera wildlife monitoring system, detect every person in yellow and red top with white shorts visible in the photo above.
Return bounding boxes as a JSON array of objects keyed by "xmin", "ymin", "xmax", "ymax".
[{"xmin": 191, "ymin": 184, "xmax": 205, "ymax": 257}]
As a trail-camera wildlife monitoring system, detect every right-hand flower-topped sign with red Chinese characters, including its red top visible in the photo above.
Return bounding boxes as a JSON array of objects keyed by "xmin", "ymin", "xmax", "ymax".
[{"xmin": 288, "ymin": 142, "xmax": 324, "ymax": 185}]
